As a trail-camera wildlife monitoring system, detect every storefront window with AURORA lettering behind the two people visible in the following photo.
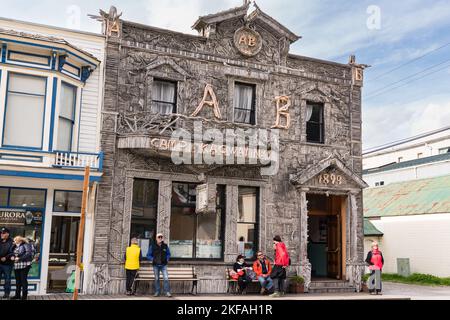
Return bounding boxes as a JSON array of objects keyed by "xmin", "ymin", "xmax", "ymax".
[{"xmin": 0, "ymin": 188, "xmax": 46, "ymax": 279}]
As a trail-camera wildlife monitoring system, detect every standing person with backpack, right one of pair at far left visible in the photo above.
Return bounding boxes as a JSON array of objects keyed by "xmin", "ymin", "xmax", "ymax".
[{"xmin": 11, "ymin": 236, "xmax": 33, "ymax": 300}]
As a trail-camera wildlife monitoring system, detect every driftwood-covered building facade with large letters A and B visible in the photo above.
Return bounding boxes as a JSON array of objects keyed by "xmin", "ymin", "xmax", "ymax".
[{"xmin": 88, "ymin": 4, "xmax": 366, "ymax": 294}]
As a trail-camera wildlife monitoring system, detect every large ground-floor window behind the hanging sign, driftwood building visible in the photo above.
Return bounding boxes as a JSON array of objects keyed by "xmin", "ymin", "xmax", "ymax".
[{"xmin": 170, "ymin": 183, "xmax": 225, "ymax": 260}]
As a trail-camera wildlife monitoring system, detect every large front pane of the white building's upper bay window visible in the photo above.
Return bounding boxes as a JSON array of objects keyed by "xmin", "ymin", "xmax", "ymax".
[{"xmin": 3, "ymin": 73, "xmax": 47, "ymax": 149}]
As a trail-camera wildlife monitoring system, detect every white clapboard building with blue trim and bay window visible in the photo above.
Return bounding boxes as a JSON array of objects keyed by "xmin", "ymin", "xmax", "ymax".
[{"xmin": 0, "ymin": 18, "xmax": 105, "ymax": 294}]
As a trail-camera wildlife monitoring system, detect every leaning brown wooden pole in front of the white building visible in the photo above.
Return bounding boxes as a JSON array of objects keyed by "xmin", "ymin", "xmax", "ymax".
[{"xmin": 73, "ymin": 166, "xmax": 91, "ymax": 300}]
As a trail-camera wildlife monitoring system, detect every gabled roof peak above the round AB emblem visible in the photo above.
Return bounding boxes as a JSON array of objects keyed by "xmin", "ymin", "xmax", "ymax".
[{"xmin": 192, "ymin": 3, "xmax": 301, "ymax": 43}]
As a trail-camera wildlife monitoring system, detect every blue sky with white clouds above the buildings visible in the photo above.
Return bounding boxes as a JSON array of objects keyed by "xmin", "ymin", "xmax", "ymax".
[{"xmin": 0, "ymin": 0, "xmax": 450, "ymax": 149}]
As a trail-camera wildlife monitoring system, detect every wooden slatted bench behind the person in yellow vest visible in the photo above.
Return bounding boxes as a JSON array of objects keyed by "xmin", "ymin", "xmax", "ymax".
[{"xmin": 133, "ymin": 267, "xmax": 198, "ymax": 295}]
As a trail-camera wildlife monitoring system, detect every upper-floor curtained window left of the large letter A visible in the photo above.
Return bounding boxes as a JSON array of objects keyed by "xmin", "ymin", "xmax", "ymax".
[{"xmin": 152, "ymin": 80, "xmax": 177, "ymax": 115}]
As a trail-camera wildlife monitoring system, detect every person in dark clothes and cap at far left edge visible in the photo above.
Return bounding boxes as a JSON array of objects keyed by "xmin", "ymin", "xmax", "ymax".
[{"xmin": 0, "ymin": 228, "xmax": 14, "ymax": 299}]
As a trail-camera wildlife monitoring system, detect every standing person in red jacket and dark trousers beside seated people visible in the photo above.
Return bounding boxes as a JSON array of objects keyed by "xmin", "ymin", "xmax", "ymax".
[{"xmin": 270, "ymin": 236, "xmax": 291, "ymax": 298}]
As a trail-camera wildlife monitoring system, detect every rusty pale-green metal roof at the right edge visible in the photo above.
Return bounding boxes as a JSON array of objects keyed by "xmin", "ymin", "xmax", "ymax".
[{"xmin": 363, "ymin": 175, "xmax": 450, "ymax": 218}]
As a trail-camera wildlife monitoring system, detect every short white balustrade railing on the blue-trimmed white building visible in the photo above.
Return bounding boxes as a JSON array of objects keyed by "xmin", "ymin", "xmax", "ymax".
[{"xmin": 54, "ymin": 151, "xmax": 103, "ymax": 171}]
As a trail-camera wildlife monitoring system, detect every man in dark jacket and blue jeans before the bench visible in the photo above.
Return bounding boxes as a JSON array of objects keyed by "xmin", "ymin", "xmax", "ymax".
[{"xmin": 147, "ymin": 233, "xmax": 172, "ymax": 298}]
